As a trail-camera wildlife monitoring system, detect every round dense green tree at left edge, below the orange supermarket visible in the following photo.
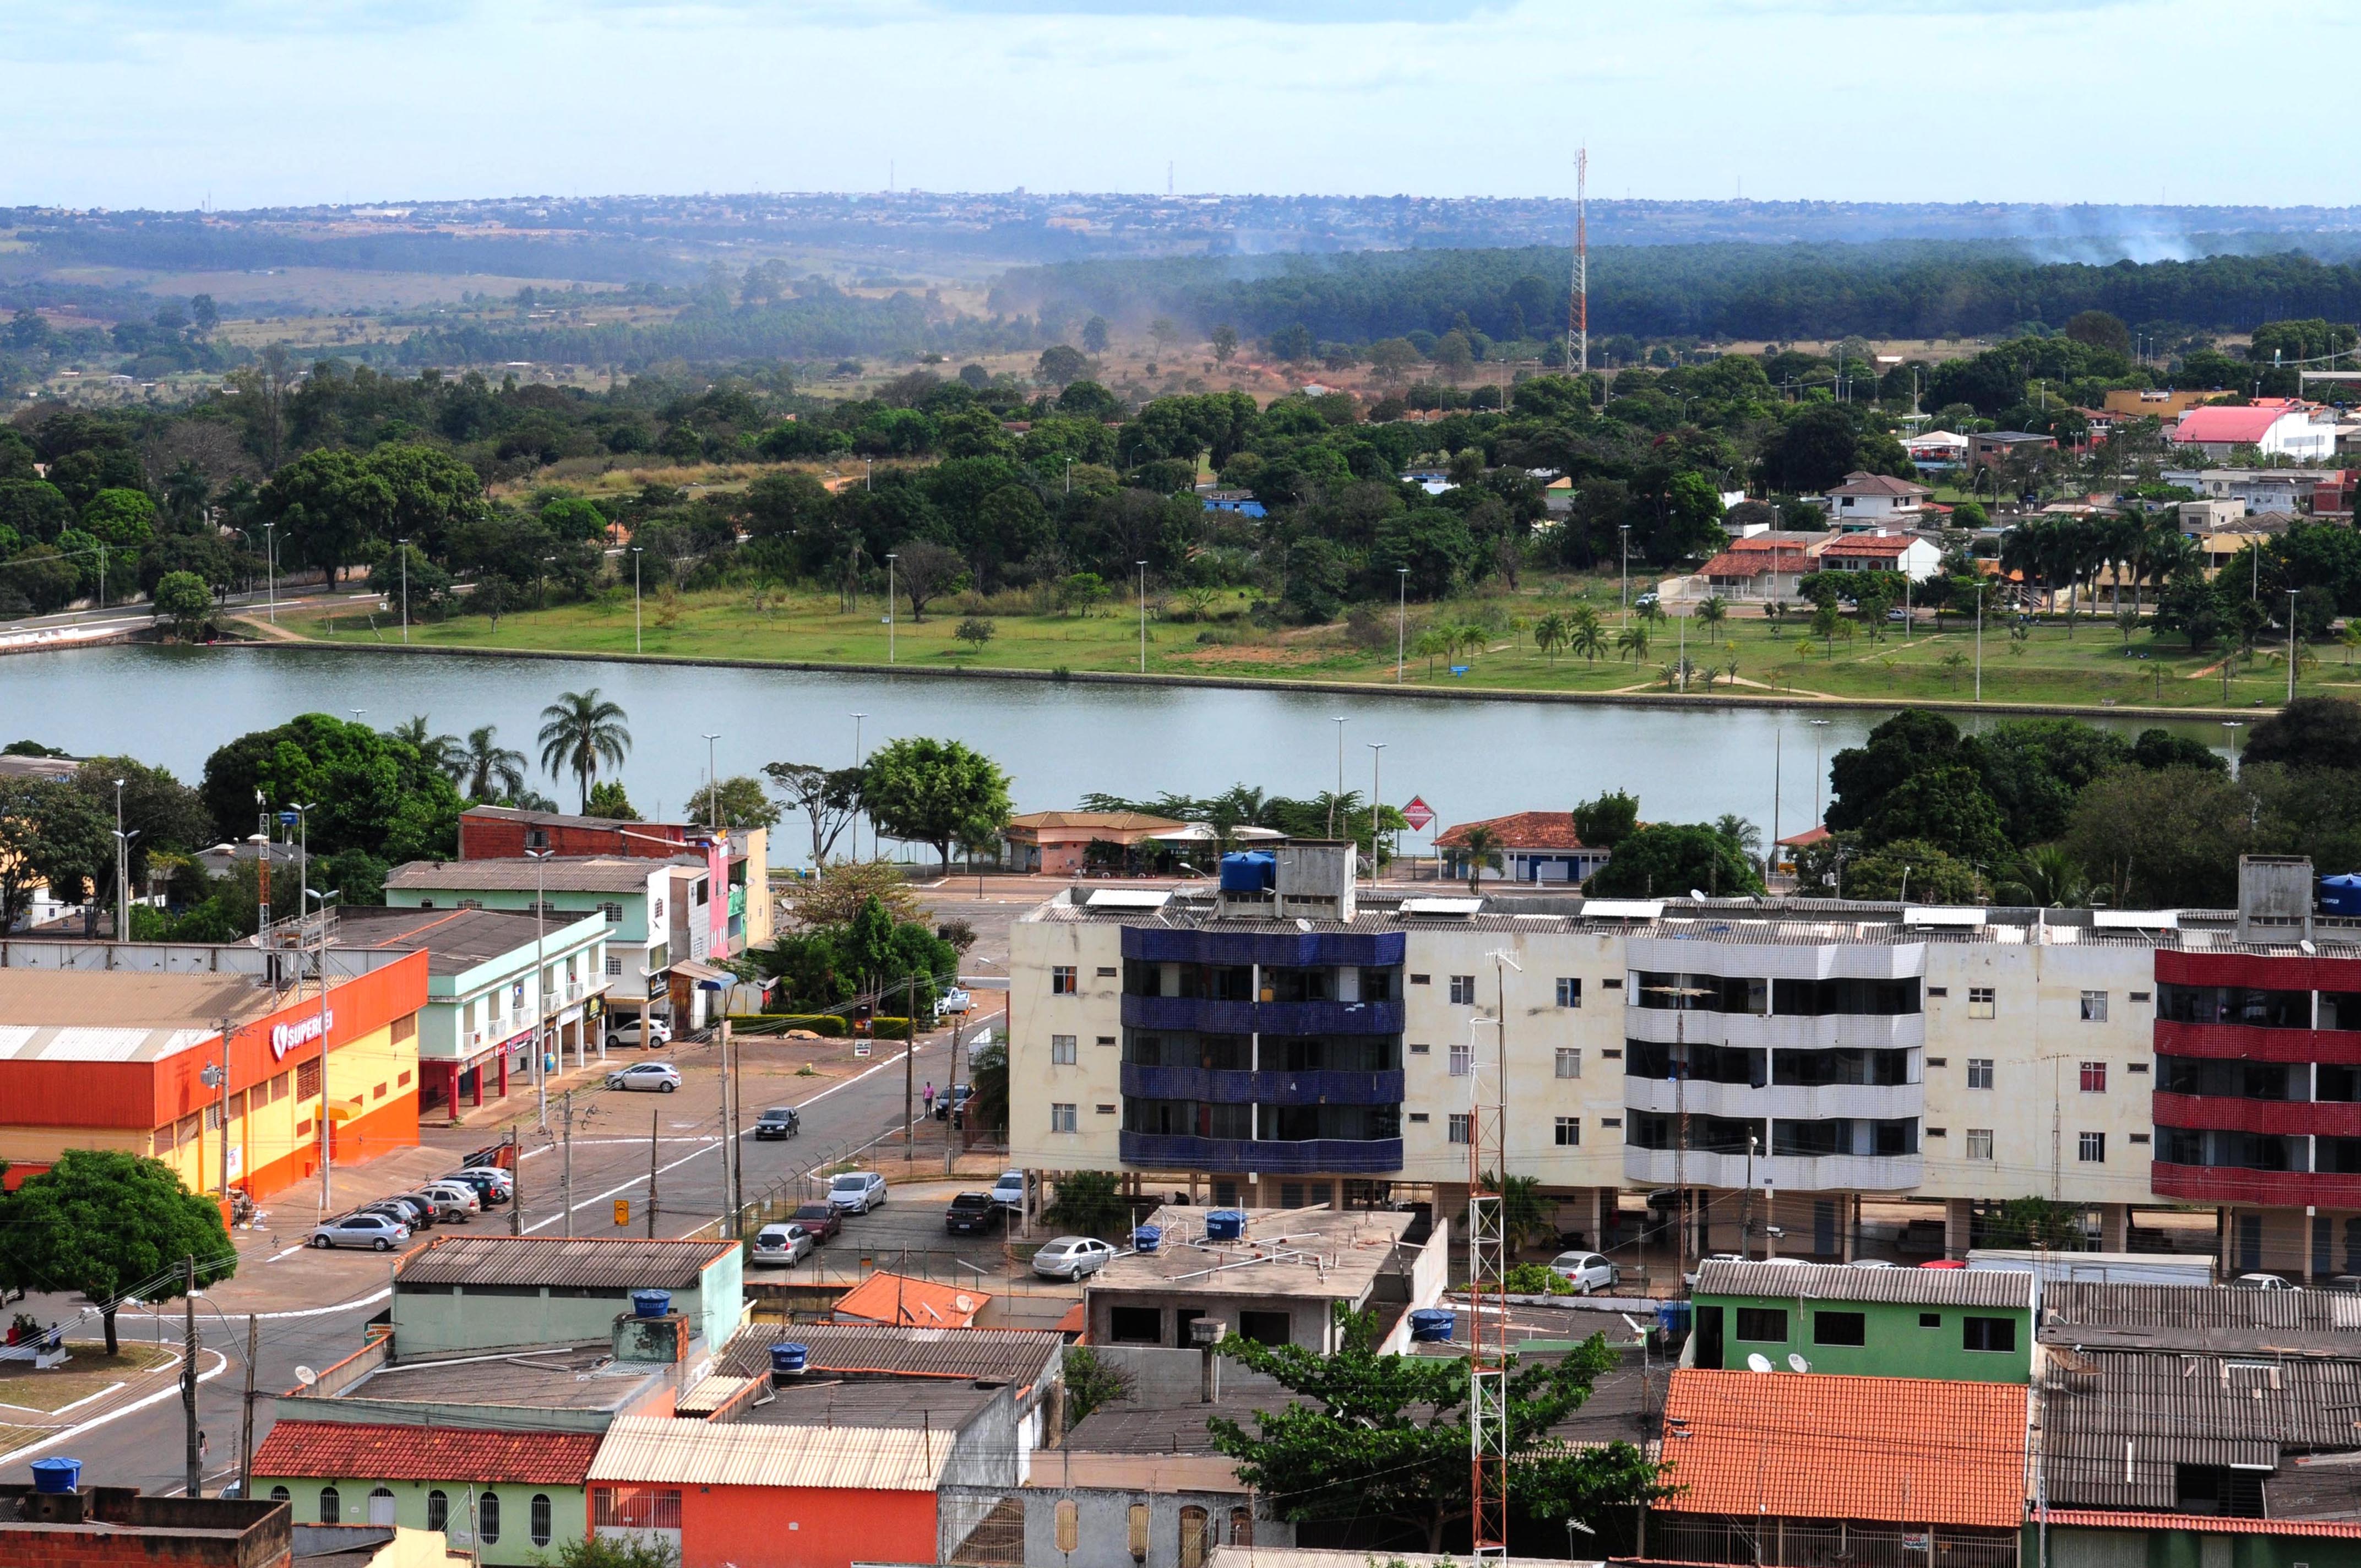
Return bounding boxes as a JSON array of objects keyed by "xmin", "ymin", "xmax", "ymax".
[{"xmin": 0, "ymin": 1148, "xmax": 238, "ymax": 1355}]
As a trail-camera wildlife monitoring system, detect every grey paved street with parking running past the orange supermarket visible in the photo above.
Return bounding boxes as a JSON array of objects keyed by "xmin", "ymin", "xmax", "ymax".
[{"xmin": 0, "ymin": 1015, "xmax": 996, "ymax": 1493}]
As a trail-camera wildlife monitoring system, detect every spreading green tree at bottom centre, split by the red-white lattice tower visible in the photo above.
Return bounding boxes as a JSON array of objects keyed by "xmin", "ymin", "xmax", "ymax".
[{"xmin": 1206, "ymin": 1304, "xmax": 1657, "ymax": 1551}]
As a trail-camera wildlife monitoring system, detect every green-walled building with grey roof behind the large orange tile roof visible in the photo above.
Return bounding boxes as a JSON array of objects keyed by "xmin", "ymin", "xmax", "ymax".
[{"xmin": 1690, "ymin": 1259, "xmax": 2040, "ymax": 1384}]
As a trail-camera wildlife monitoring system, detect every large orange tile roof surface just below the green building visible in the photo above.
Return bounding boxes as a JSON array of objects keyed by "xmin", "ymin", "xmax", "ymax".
[{"xmin": 1664, "ymin": 1367, "xmax": 2054, "ymax": 1530}]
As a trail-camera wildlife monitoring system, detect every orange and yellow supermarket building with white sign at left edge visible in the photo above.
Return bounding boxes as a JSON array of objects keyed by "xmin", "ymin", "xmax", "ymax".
[{"xmin": 0, "ymin": 938, "xmax": 427, "ymax": 1197}]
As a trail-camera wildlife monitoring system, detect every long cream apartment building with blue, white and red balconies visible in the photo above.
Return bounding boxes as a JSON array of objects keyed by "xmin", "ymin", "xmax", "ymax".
[{"xmin": 1010, "ymin": 846, "xmax": 2361, "ymax": 1273}]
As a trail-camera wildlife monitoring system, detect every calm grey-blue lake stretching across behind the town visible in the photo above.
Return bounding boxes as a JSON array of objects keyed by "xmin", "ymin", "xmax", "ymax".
[{"xmin": 0, "ymin": 643, "xmax": 2227, "ymax": 862}]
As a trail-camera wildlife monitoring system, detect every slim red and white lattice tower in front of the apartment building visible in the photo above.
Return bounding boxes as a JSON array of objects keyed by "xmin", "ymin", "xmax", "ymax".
[{"xmin": 1468, "ymin": 952, "xmax": 1523, "ymax": 1563}]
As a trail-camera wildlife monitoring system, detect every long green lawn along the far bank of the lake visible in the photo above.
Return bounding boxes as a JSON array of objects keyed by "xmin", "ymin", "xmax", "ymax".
[{"xmin": 284, "ymin": 579, "xmax": 2361, "ymax": 709}]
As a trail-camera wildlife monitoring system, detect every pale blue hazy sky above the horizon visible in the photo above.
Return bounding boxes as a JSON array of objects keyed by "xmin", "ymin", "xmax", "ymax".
[{"xmin": 0, "ymin": 0, "xmax": 2361, "ymax": 208}]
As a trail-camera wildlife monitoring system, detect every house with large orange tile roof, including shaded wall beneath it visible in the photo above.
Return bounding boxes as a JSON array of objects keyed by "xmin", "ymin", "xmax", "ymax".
[{"xmin": 1639, "ymin": 1365, "xmax": 2026, "ymax": 1568}]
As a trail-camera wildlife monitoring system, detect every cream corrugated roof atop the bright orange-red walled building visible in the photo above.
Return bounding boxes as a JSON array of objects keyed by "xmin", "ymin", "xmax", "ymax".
[{"xmin": 590, "ymin": 1417, "xmax": 951, "ymax": 1493}]
